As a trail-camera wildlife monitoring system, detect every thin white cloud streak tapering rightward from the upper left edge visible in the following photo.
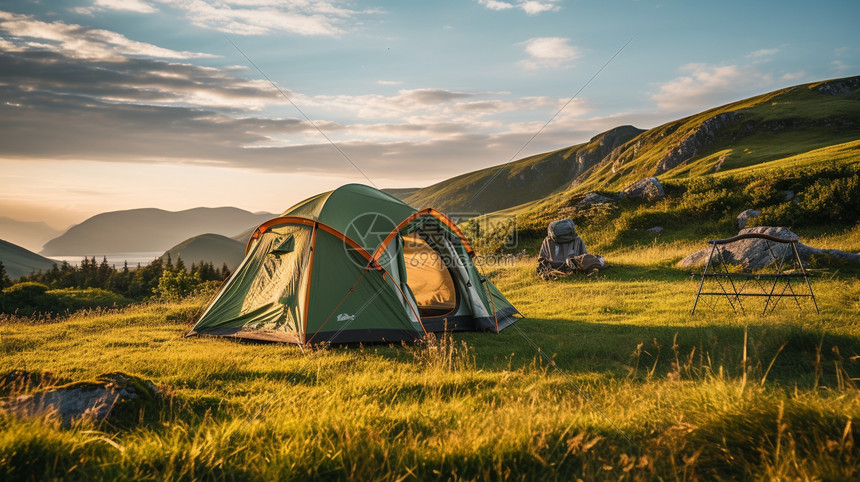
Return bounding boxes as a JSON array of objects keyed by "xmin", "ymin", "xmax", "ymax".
[{"xmin": 0, "ymin": 11, "xmax": 212, "ymax": 61}]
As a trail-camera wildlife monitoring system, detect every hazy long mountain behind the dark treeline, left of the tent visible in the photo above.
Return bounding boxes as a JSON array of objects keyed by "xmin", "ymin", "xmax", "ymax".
[{"xmin": 41, "ymin": 207, "xmax": 274, "ymax": 255}]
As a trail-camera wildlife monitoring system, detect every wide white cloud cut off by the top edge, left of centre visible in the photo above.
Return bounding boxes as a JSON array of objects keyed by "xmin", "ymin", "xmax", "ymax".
[{"xmin": 150, "ymin": 0, "xmax": 370, "ymax": 36}]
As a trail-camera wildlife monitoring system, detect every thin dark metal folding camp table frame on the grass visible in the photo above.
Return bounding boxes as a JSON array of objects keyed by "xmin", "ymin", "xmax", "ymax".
[{"xmin": 690, "ymin": 233, "xmax": 821, "ymax": 314}]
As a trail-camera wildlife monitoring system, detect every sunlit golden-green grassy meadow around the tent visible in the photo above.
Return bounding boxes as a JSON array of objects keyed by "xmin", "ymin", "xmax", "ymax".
[{"xmin": 0, "ymin": 227, "xmax": 860, "ymax": 480}]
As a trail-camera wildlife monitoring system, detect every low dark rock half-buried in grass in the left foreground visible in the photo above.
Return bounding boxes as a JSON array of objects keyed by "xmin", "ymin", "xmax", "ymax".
[{"xmin": 0, "ymin": 372, "xmax": 160, "ymax": 426}]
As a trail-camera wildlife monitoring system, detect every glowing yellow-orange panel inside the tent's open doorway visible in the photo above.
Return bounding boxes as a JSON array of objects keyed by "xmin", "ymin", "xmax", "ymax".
[{"xmin": 403, "ymin": 232, "xmax": 457, "ymax": 318}]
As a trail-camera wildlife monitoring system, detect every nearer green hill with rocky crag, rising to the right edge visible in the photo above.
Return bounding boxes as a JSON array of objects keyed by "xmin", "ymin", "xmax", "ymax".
[{"xmin": 573, "ymin": 77, "xmax": 860, "ymax": 192}]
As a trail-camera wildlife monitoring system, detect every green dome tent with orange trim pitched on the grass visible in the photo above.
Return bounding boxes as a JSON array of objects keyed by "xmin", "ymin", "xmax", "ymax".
[{"xmin": 188, "ymin": 184, "xmax": 521, "ymax": 344}]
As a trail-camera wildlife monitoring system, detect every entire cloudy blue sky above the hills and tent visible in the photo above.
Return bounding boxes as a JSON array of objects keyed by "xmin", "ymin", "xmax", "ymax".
[{"xmin": 0, "ymin": 0, "xmax": 860, "ymax": 228}]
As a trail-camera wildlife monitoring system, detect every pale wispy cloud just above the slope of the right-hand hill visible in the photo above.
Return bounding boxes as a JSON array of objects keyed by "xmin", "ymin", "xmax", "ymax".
[{"xmin": 651, "ymin": 63, "xmax": 773, "ymax": 112}]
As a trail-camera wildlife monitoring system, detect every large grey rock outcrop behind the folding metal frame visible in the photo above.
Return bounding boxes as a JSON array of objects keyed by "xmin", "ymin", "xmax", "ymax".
[{"xmin": 678, "ymin": 226, "xmax": 860, "ymax": 271}]
